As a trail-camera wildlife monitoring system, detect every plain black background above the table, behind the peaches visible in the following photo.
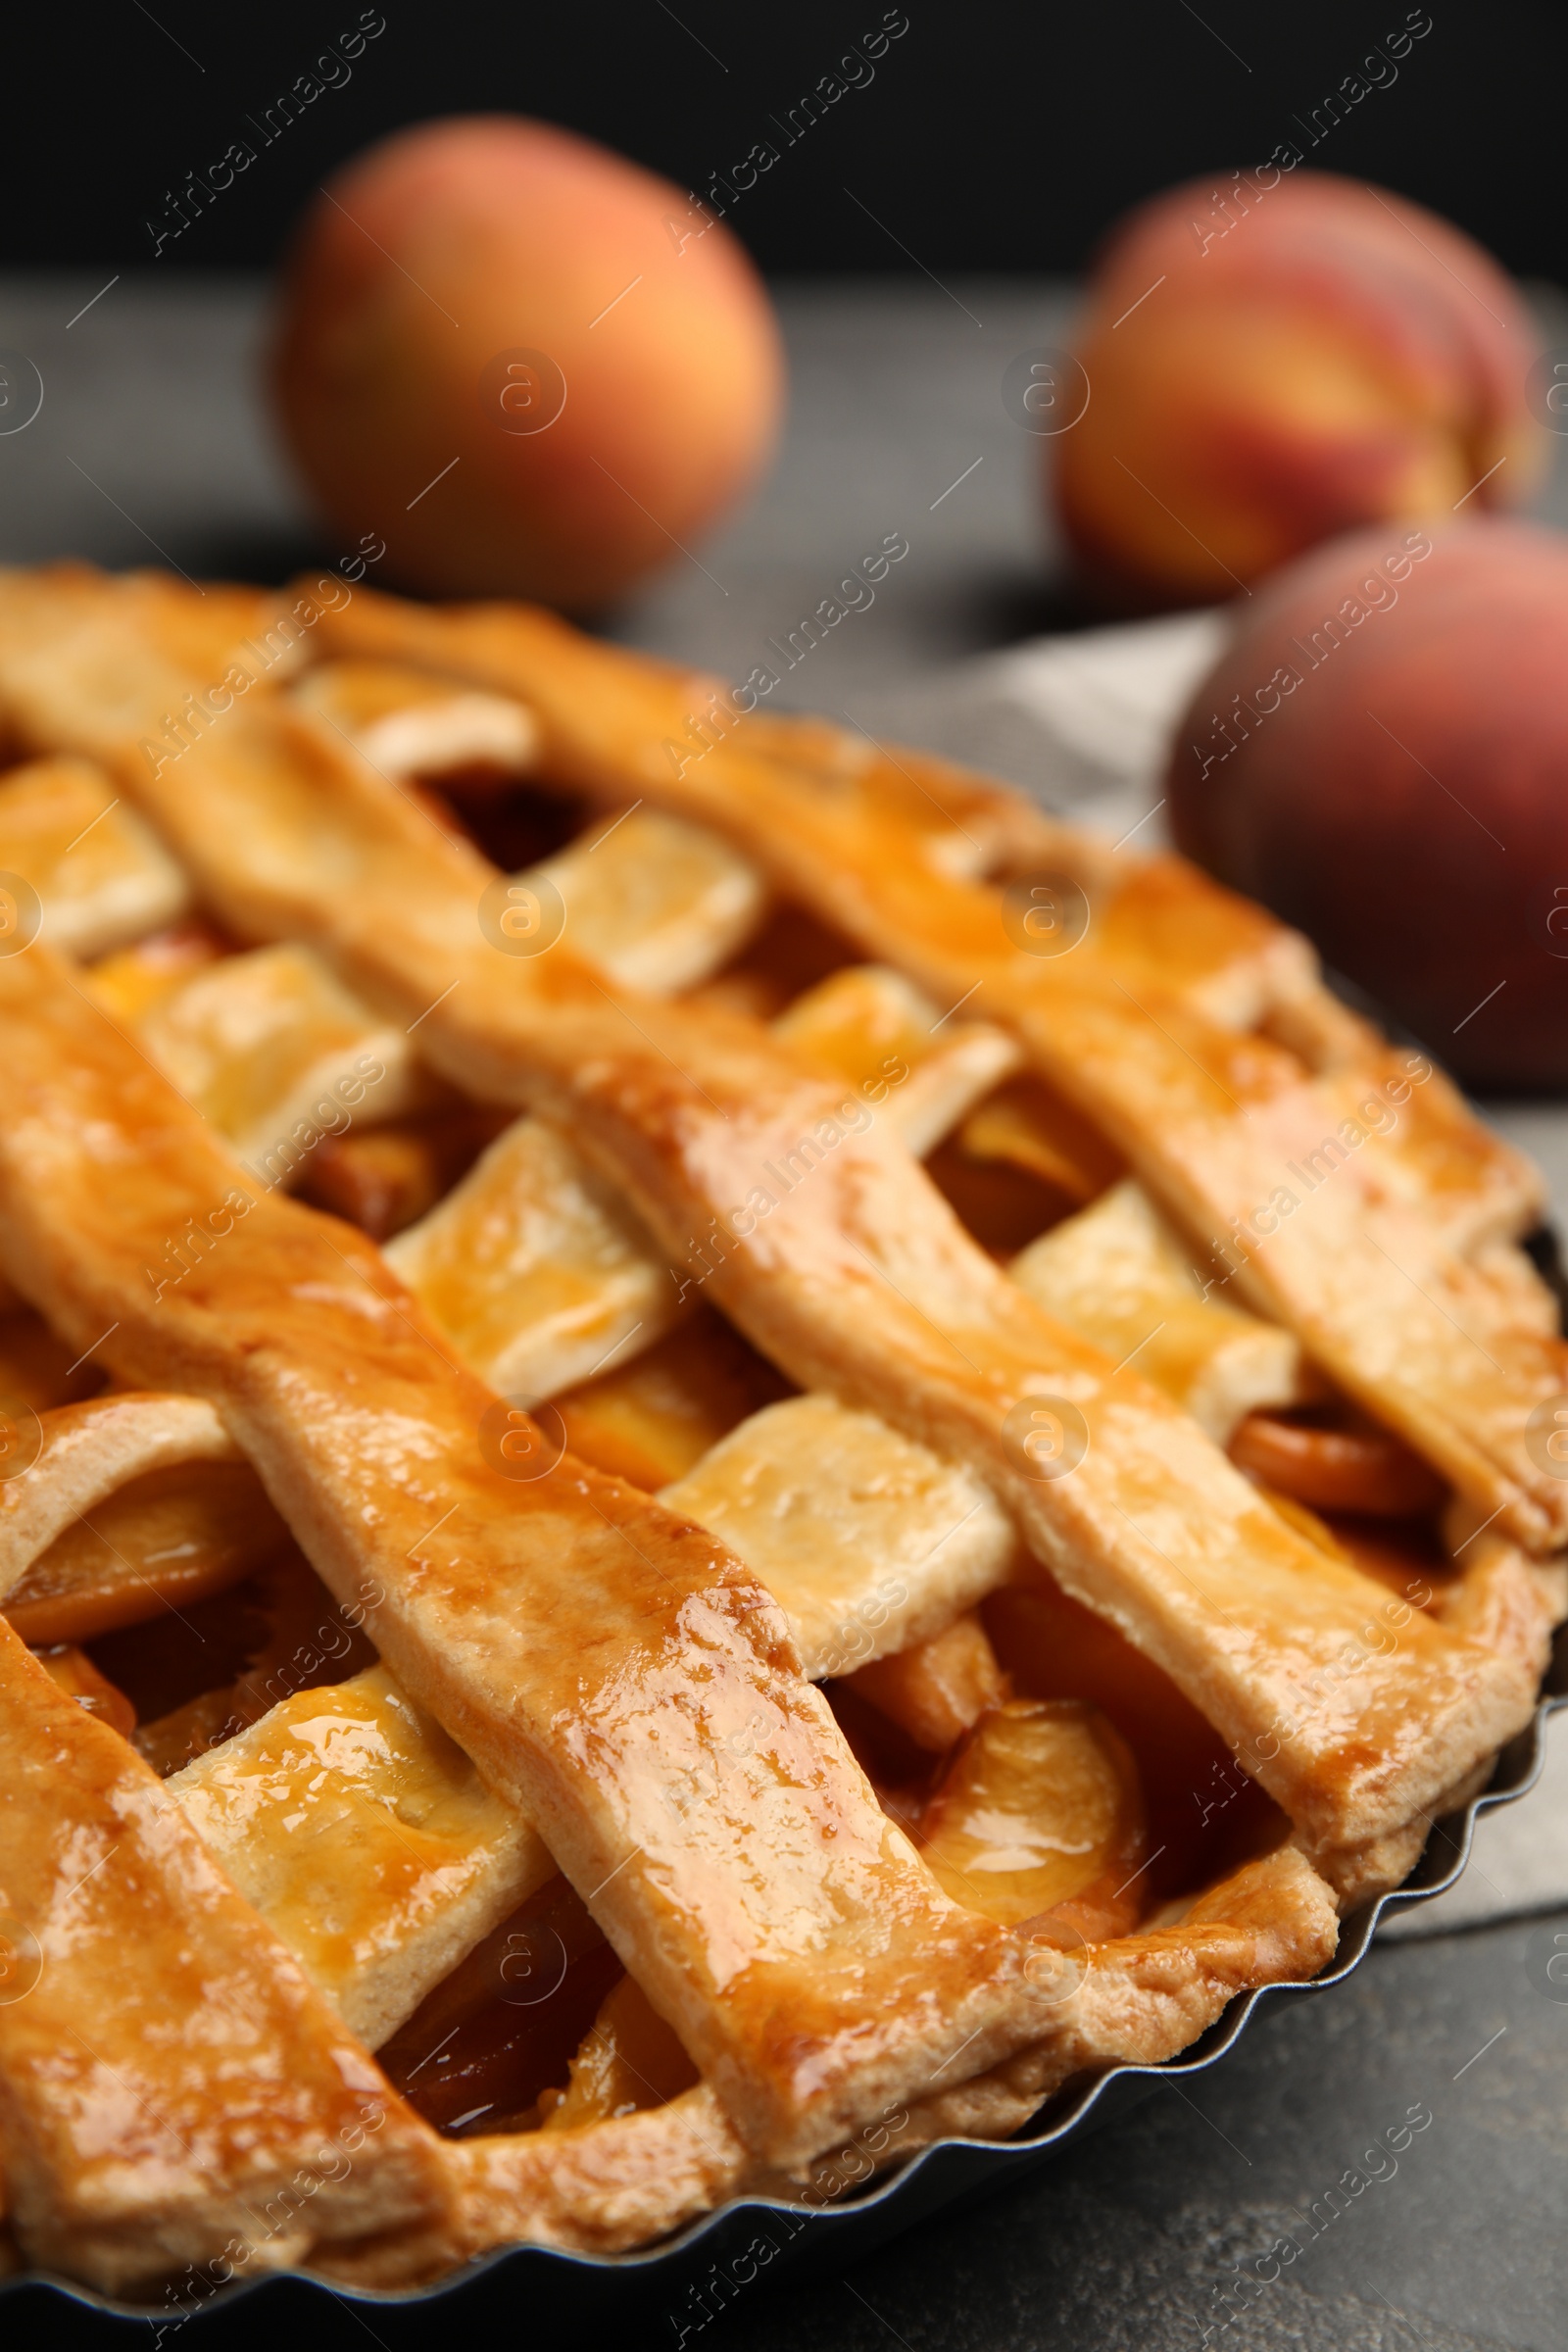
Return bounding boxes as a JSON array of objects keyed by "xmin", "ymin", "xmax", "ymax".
[{"xmin": 12, "ymin": 0, "xmax": 1568, "ymax": 280}]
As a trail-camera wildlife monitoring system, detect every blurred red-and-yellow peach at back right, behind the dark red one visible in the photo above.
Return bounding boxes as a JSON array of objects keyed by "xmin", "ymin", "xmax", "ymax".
[{"xmin": 1046, "ymin": 176, "xmax": 1544, "ymax": 610}]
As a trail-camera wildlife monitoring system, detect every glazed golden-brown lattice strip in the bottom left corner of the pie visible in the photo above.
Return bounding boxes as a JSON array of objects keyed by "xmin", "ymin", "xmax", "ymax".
[{"xmin": 0, "ymin": 1628, "xmax": 447, "ymax": 2293}]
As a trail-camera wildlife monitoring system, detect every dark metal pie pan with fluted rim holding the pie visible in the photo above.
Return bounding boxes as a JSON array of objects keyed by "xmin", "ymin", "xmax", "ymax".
[{"xmin": 0, "ymin": 1642, "xmax": 1568, "ymax": 2347}]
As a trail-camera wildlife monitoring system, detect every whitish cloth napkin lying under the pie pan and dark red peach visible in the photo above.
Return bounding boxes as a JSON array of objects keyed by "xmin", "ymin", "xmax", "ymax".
[{"xmin": 858, "ymin": 612, "xmax": 1568, "ymax": 1936}]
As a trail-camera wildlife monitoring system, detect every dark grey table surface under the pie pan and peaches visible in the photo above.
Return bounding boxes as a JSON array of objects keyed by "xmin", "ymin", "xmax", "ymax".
[{"xmin": 0, "ymin": 275, "xmax": 1568, "ymax": 2352}]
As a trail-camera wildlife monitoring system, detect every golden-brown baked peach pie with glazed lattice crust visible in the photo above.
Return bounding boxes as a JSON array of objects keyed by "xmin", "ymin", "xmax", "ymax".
[{"xmin": 0, "ymin": 566, "xmax": 1568, "ymax": 2298}]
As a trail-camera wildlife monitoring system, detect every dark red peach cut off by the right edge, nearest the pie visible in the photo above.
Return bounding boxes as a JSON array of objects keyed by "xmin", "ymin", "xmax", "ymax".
[{"xmin": 1166, "ymin": 517, "xmax": 1568, "ymax": 1089}]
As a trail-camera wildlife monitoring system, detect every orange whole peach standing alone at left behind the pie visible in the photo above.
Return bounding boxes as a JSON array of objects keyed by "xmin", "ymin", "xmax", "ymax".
[{"xmin": 272, "ymin": 116, "xmax": 783, "ymax": 607}]
